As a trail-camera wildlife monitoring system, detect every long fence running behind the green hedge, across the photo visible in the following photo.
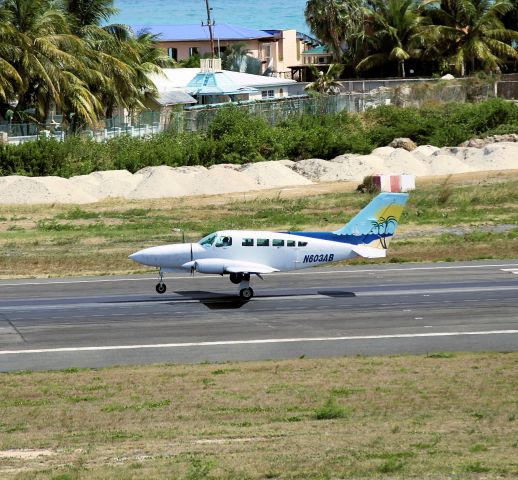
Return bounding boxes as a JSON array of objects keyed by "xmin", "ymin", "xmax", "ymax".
[{"xmin": 0, "ymin": 75, "xmax": 518, "ymax": 144}]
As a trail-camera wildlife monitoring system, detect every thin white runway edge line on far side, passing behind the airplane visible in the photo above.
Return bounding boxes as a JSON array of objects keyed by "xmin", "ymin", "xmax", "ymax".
[{"xmin": 0, "ymin": 263, "xmax": 518, "ymax": 287}]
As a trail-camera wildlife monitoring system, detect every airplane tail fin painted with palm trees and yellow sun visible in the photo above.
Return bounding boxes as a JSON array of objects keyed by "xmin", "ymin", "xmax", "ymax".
[{"xmin": 333, "ymin": 193, "xmax": 408, "ymax": 249}]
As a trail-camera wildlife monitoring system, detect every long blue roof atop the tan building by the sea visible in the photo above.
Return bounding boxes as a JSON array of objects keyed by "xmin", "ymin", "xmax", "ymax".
[{"xmin": 131, "ymin": 23, "xmax": 273, "ymax": 41}]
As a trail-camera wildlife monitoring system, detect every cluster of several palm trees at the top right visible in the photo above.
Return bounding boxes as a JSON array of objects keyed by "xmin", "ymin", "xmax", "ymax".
[{"xmin": 305, "ymin": 0, "xmax": 518, "ymax": 77}]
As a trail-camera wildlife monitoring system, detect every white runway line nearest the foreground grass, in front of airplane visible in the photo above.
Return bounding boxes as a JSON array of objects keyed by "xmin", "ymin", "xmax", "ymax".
[{"xmin": 0, "ymin": 330, "xmax": 518, "ymax": 355}]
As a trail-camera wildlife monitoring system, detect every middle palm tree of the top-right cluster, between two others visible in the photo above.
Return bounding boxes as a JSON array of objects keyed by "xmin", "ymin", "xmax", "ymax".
[{"xmin": 356, "ymin": 0, "xmax": 427, "ymax": 77}]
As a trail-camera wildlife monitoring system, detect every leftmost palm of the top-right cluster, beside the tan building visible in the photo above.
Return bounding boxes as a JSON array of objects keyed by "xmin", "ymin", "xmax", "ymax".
[{"xmin": 304, "ymin": 0, "xmax": 363, "ymax": 62}]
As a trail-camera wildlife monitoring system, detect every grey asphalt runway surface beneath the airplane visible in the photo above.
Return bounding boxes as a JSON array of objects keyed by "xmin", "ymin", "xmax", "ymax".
[{"xmin": 0, "ymin": 260, "xmax": 518, "ymax": 371}]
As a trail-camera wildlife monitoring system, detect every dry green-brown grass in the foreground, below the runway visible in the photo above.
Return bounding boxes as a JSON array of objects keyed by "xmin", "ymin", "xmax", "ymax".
[{"xmin": 0, "ymin": 353, "xmax": 518, "ymax": 479}]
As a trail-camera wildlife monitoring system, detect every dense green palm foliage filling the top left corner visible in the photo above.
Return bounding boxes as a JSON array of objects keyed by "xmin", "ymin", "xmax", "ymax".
[{"xmin": 0, "ymin": 0, "xmax": 170, "ymax": 124}]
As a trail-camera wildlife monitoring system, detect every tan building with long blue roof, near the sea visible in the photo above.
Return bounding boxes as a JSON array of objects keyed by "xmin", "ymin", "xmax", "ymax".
[{"xmin": 132, "ymin": 24, "xmax": 319, "ymax": 78}]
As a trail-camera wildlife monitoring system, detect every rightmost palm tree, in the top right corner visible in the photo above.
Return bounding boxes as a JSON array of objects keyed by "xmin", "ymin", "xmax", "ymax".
[{"xmin": 424, "ymin": 0, "xmax": 518, "ymax": 76}]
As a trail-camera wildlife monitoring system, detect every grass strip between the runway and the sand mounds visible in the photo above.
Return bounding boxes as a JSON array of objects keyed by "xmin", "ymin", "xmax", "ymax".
[{"xmin": 0, "ymin": 172, "xmax": 518, "ymax": 277}]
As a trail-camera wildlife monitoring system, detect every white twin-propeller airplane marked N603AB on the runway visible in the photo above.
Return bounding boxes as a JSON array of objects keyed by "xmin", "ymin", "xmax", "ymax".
[{"xmin": 129, "ymin": 193, "xmax": 408, "ymax": 301}]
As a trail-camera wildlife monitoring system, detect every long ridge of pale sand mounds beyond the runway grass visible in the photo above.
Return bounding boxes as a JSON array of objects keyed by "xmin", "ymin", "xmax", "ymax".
[{"xmin": 0, "ymin": 135, "xmax": 518, "ymax": 204}]
